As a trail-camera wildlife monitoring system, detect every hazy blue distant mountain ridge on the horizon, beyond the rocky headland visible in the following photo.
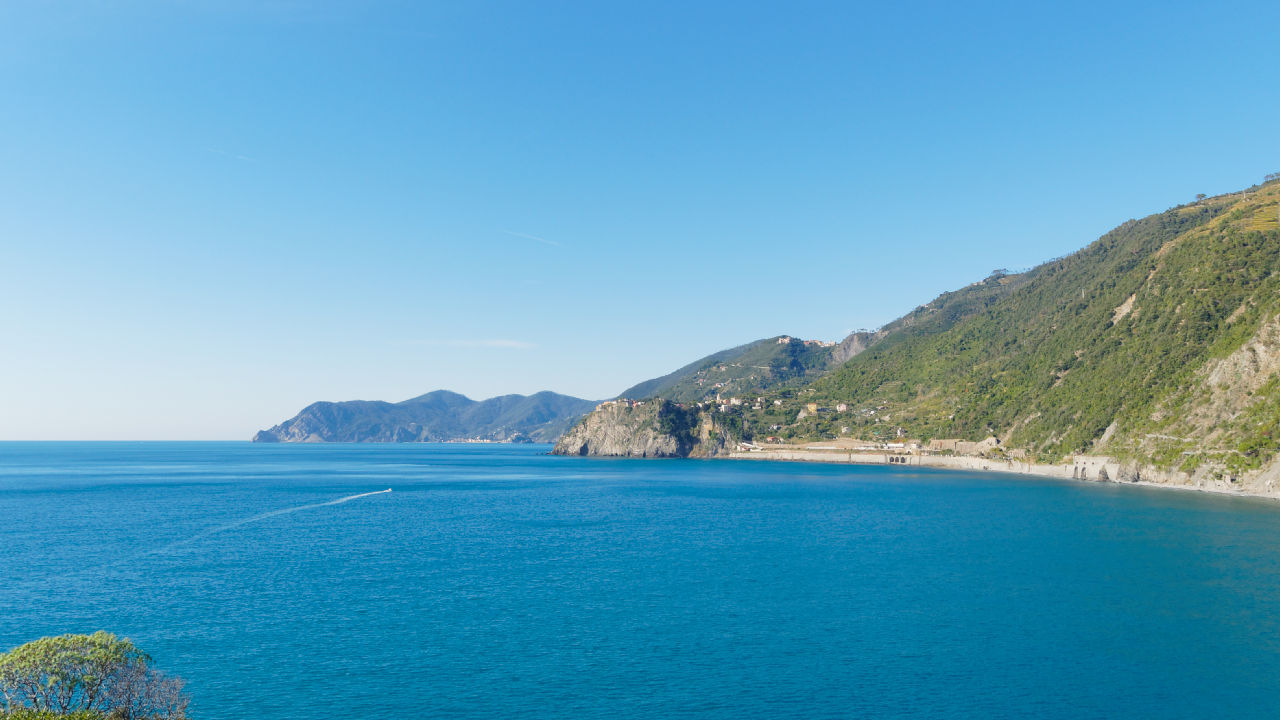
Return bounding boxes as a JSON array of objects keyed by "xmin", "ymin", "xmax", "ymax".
[{"xmin": 253, "ymin": 389, "xmax": 595, "ymax": 442}]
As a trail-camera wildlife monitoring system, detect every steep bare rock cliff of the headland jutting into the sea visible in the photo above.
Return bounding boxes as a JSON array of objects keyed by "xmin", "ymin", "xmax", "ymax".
[{"xmin": 552, "ymin": 400, "xmax": 696, "ymax": 457}]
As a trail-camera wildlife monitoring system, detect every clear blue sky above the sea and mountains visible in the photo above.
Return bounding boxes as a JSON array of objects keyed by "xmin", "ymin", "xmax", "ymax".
[{"xmin": 0, "ymin": 0, "xmax": 1280, "ymax": 439}]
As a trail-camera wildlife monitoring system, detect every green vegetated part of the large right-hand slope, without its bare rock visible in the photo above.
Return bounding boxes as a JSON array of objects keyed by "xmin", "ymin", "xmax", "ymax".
[{"xmin": 813, "ymin": 187, "xmax": 1280, "ymax": 456}]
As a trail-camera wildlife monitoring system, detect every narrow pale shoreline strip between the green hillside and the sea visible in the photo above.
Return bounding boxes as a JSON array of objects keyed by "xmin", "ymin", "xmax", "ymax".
[{"xmin": 710, "ymin": 450, "xmax": 1280, "ymax": 501}]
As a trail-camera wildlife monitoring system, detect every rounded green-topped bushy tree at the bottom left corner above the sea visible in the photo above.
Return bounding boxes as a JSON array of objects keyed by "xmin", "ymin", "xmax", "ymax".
[{"xmin": 0, "ymin": 632, "xmax": 188, "ymax": 720}]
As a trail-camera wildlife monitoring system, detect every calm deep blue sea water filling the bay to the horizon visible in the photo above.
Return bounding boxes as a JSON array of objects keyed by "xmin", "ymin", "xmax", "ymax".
[{"xmin": 0, "ymin": 443, "xmax": 1280, "ymax": 720}]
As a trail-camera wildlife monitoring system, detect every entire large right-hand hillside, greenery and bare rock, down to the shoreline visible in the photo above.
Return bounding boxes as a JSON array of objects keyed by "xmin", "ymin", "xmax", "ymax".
[{"xmin": 744, "ymin": 174, "xmax": 1280, "ymax": 468}]
